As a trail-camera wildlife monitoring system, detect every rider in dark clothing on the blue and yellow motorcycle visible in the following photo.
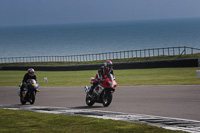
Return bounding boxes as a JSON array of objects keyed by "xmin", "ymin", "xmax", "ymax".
[{"xmin": 20, "ymin": 68, "xmax": 37, "ymax": 95}]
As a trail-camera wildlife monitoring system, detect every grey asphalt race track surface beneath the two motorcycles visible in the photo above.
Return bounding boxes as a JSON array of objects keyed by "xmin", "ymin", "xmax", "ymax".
[{"xmin": 0, "ymin": 85, "xmax": 200, "ymax": 121}]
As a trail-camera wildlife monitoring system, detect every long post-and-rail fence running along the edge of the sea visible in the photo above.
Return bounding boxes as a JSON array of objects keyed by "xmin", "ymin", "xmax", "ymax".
[{"xmin": 0, "ymin": 46, "xmax": 200, "ymax": 63}]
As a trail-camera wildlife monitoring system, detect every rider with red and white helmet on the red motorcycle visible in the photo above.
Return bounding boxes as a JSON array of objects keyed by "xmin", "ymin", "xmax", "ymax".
[{"xmin": 88, "ymin": 60, "xmax": 114, "ymax": 96}]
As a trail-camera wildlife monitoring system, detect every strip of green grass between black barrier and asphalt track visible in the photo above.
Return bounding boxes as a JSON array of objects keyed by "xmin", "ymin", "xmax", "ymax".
[{"xmin": 0, "ymin": 67, "xmax": 200, "ymax": 87}]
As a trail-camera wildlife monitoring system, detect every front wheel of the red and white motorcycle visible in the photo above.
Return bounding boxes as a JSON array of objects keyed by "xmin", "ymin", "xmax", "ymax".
[{"xmin": 102, "ymin": 90, "xmax": 113, "ymax": 107}]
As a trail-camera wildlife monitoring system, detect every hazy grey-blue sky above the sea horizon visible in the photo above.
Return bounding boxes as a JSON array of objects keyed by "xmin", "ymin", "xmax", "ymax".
[{"xmin": 0, "ymin": 0, "xmax": 200, "ymax": 26}]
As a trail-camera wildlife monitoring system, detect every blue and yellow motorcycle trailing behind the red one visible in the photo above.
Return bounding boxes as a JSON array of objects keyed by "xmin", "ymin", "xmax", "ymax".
[{"xmin": 18, "ymin": 79, "xmax": 39, "ymax": 105}]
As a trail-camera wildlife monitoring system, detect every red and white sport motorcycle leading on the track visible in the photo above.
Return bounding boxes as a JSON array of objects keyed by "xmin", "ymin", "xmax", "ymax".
[{"xmin": 84, "ymin": 74, "xmax": 117, "ymax": 107}]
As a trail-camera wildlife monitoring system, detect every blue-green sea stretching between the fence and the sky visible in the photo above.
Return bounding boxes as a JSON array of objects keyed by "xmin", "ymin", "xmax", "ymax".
[{"xmin": 0, "ymin": 18, "xmax": 200, "ymax": 58}]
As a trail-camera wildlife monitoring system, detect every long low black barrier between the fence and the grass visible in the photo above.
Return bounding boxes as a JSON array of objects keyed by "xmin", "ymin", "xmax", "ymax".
[{"xmin": 1, "ymin": 58, "xmax": 199, "ymax": 71}]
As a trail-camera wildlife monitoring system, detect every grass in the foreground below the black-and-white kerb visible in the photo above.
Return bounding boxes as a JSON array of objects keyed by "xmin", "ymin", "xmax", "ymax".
[{"xmin": 0, "ymin": 109, "xmax": 182, "ymax": 133}]
